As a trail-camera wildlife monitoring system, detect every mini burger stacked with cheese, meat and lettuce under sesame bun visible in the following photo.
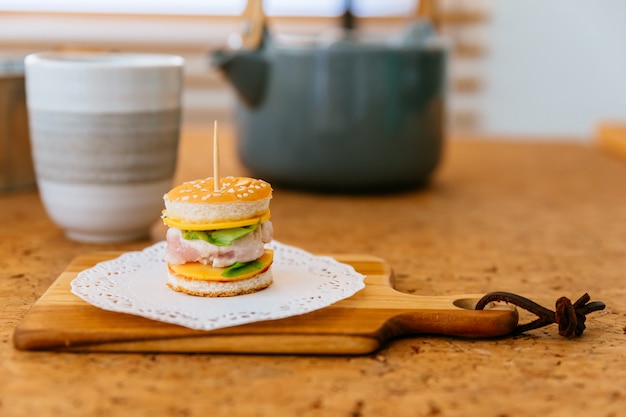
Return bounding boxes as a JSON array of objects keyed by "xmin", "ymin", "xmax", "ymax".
[{"xmin": 162, "ymin": 177, "xmax": 274, "ymax": 297}]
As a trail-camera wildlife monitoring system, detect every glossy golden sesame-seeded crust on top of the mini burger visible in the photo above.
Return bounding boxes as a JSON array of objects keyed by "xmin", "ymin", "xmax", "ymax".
[{"xmin": 164, "ymin": 177, "xmax": 272, "ymax": 204}]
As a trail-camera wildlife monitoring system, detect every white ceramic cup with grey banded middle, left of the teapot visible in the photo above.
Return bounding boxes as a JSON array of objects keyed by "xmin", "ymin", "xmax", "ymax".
[{"xmin": 25, "ymin": 52, "xmax": 184, "ymax": 243}]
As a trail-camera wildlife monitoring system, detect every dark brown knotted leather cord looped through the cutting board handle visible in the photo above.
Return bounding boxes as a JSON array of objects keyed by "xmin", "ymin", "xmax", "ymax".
[{"xmin": 475, "ymin": 292, "xmax": 606, "ymax": 337}]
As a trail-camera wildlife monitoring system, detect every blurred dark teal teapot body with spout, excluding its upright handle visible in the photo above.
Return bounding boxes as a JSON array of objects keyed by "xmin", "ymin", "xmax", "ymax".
[{"xmin": 211, "ymin": 13, "xmax": 447, "ymax": 192}]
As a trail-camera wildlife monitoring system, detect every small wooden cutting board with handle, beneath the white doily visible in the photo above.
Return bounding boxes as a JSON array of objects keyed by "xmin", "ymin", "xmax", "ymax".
[{"xmin": 13, "ymin": 252, "xmax": 518, "ymax": 354}]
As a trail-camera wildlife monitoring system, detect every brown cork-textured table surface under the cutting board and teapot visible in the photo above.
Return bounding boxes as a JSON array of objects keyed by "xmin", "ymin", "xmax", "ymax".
[{"xmin": 0, "ymin": 126, "xmax": 626, "ymax": 417}]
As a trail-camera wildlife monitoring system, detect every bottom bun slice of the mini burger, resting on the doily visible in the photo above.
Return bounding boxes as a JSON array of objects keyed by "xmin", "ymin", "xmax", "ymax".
[{"xmin": 167, "ymin": 267, "xmax": 273, "ymax": 297}]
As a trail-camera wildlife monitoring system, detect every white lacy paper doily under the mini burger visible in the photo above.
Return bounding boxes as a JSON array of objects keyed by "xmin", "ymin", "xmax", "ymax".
[{"xmin": 71, "ymin": 241, "xmax": 365, "ymax": 330}]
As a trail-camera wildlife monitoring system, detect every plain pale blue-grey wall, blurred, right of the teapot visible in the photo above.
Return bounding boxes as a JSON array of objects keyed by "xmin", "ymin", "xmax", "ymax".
[{"xmin": 481, "ymin": 0, "xmax": 626, "ymax": 140}]
